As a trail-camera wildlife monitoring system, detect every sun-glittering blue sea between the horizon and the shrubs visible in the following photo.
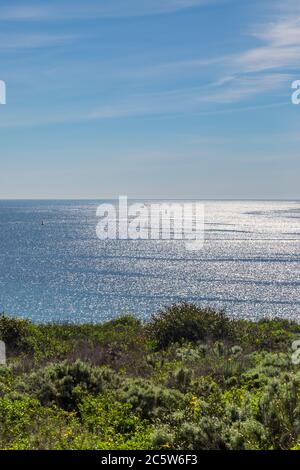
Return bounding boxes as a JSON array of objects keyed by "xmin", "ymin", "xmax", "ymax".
[{"xmin": 0, "ymin": 201, "xmax": 300, "ymax": 323}]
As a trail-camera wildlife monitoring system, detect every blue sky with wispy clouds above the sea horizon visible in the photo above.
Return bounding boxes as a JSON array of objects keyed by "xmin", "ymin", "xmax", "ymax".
[{"xmin": 0, "ymin": 0, "xmax": 300, "ymax": 199}]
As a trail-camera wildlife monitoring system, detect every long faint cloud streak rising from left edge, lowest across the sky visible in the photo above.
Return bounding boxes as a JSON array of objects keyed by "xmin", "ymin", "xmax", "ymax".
[{"xmin": 0, "ymin": 74, "xmax": 290, "ymax": 128}]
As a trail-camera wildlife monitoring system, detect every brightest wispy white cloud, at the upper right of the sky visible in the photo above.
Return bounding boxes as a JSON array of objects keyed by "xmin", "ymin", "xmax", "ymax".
[{"xmin": 114, "ymin": 0, "xmax": 300, "ymax": 102}]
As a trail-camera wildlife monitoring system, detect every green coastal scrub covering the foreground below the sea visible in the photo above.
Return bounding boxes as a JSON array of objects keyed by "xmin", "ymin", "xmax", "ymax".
[{"xmin": 0, "ymin": 304, "xmax": 300, "ymax": 450}]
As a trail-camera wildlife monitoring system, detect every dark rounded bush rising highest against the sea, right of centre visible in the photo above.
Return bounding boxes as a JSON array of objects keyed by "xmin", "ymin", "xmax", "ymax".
[{"xmin": 148, "ymin": 303, "xmax": 232, "ymax": 348}]
